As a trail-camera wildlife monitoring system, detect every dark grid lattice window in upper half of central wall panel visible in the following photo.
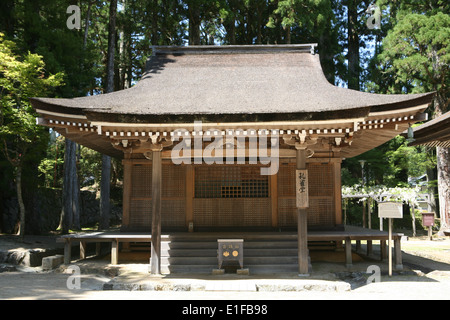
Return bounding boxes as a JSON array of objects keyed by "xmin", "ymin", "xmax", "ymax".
[{"xmin": 195, "ymin": 166, "xmax": 269, "ymax": 198}]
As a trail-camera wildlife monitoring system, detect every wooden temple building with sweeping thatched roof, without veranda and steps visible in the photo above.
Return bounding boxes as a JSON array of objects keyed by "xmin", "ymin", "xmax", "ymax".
[{"xmin": 32, "ymin": 44, "xmax": 432, "ymax": 274}]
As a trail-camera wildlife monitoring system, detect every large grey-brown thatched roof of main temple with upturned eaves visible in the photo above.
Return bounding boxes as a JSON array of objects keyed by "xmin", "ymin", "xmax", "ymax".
[{"xmin": 31, "ymin": 45, "xmax": 431, "ymax": 123}]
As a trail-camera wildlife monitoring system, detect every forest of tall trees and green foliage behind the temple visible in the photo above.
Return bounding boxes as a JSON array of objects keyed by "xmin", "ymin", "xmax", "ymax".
[{"xmin": 0, "ymin": 0, "xmax": 450, "ymax": 235}]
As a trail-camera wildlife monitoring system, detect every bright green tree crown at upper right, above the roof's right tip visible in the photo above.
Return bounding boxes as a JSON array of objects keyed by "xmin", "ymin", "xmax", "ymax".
[{"xmin": 380, "ymin": 12, "xmax": 450, "ymax": 95}]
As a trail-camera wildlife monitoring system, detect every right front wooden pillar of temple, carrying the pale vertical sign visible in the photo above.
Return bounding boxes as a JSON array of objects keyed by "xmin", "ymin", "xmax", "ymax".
[{"xmin": 296, "ymin": 148, "xmax": 309, "ymax": 275}]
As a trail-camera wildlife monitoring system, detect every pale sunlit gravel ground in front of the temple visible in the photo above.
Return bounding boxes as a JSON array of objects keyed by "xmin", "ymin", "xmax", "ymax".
[{"xmin": 0, "ymin": 236, "xmax": 450, "ymax": 302}]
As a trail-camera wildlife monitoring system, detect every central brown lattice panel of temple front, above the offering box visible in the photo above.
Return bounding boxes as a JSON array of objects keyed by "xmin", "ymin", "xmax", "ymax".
[{"xmin": 193, "ymin": 165, "xmax": 271, "ymax": 227}]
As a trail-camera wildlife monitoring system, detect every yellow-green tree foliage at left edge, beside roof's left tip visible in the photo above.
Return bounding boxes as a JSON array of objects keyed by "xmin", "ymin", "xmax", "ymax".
[{"xmin": 0, "ymin": 33, "xmax": 62, "ymax": 167}]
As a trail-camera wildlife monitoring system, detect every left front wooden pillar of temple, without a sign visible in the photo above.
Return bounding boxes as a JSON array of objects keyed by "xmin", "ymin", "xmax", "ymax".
[{"xmin": 150, "ymin": 150, "xmax": 162, "ymax": 274}]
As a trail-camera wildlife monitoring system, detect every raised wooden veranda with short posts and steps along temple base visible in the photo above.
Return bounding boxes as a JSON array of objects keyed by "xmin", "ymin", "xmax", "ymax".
[{"xmin": 57, "ymin": 226, "xmax": 403, "ymax": 273}]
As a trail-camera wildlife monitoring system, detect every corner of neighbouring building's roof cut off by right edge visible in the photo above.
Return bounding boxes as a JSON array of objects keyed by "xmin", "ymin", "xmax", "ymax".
[{"xmin": 410, "ymin": 112, "xmax": 450, "ymax": 148}]
